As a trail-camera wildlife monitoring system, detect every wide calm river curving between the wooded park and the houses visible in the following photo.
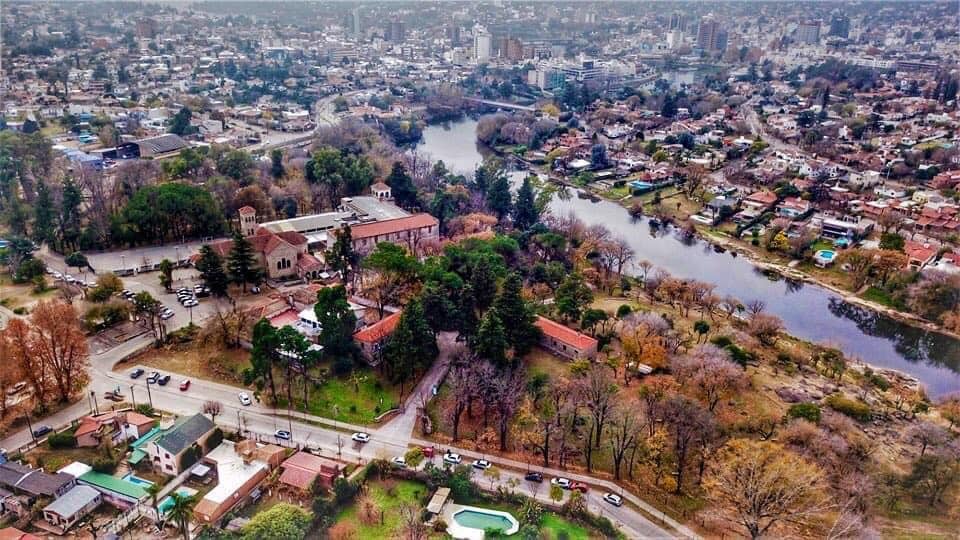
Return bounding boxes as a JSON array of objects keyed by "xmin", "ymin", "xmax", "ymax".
[{"xmin": 417, "ymin": 119, "xmax": 960, "ymax": 396}]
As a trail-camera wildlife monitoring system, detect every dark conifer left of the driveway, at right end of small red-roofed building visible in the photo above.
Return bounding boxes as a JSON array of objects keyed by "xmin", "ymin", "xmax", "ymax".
[{"xmin": 384, "ymin": 299, "xmax": 440, "ymax": 395}]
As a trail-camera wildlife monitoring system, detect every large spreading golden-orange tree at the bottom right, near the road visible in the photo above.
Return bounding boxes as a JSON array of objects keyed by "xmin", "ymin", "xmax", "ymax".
[{"xmin": 706, "ymin": 439, "xmax": 827, "ymax": 538}]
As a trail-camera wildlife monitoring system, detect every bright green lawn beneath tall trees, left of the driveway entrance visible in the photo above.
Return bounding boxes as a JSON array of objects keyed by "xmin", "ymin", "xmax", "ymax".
[{"xmin": 277, "ymin": 367, "xmax": 402, "ymax": 424}]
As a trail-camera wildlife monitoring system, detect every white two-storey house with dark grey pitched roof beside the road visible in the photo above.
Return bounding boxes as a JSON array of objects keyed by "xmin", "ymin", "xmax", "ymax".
[{"xmin": 141, "ymin": 413, "xmax": 216, "ymax": 476}]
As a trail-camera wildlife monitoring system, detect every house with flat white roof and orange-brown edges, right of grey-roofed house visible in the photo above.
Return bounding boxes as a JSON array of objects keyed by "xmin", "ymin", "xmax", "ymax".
[{"xmin": 194, "ymin": 440, "xmax": 285, "ymax": 523}]
